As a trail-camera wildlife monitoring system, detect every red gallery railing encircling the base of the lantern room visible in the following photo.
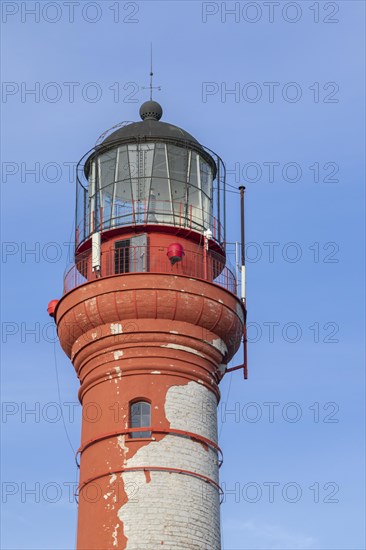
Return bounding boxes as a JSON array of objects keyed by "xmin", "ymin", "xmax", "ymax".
[{"xmin": 64, "ymin": 246, "xmax": 237, "ymax": 294}]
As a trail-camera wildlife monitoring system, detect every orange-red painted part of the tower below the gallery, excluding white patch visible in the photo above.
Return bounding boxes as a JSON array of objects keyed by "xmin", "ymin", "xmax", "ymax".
[{"xmin": 56, "ymin": 270, "xmax": 242, "ymax": 550}]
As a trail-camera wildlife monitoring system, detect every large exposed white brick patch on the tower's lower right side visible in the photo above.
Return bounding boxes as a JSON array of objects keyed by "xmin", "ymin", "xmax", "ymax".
[{"xmin": 116, "ymin": 381, "xmax": 221, "ymax": 550}]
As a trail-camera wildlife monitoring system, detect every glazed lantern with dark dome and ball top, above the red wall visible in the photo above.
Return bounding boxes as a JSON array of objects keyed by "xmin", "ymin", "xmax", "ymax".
[{"xmin": 76, "ymin": 101, "xmax": 225, "ymax": 247}]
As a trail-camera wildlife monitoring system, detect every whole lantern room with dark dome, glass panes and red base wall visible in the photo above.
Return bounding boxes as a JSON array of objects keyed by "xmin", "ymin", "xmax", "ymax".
[{"xmin": 65, "ymin": 101, "xmax": 236, "ymax": 292}]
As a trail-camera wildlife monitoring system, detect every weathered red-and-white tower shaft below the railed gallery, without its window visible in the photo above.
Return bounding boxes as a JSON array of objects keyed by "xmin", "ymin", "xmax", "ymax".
[{"xmin": 56, "ymin": 248, "xmax": 242, "ymax": 550}]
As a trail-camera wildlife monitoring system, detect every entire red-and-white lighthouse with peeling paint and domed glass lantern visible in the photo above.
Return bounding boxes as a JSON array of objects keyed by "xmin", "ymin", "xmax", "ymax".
[{"xmin": 49, "ymin": 101, "xmax": 245, "ymax": 550}]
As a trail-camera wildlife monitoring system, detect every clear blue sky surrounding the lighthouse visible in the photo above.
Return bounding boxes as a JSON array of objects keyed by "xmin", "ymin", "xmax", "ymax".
[{"xmin": 1, "ymin": 0, "xmax": 365, "ymax": 550}]
